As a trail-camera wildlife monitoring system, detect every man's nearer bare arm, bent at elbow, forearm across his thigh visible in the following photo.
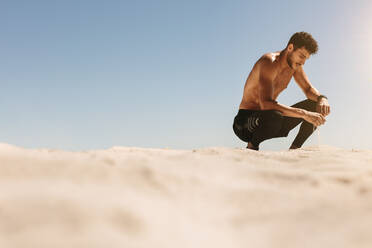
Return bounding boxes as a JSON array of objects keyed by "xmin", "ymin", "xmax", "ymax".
[{"xmin": 259, "ymin": 61, "xmax": 325, "ymax": 126}]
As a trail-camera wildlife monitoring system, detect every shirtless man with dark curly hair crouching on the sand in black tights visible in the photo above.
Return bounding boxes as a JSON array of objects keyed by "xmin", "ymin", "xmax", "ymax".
[{"xmin": 233, "ymin": 32, "xmax": 330, "ymax": 150}]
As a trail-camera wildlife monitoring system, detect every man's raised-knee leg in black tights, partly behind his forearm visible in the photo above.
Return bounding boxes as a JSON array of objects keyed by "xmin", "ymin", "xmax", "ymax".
[{"xmin": 279, "ymin": 99, "xmax": 316, "ymax": 149}]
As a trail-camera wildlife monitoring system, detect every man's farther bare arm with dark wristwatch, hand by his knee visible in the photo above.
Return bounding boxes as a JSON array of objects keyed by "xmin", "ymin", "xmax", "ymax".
[{"xmin": 293, "ymin": 66, "xmax": 331, "ymax": 116}]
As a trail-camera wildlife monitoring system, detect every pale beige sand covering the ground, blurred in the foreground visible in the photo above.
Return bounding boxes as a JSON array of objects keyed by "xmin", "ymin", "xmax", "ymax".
[{"xmin": 0, "ymin": 144, "xmax": 372, "ymax": 248}]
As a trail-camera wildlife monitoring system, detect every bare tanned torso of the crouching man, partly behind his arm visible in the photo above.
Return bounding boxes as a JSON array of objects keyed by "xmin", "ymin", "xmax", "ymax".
[{"xmin": 239, "ymin": 52, "xmax": 295, "ymax": 110}]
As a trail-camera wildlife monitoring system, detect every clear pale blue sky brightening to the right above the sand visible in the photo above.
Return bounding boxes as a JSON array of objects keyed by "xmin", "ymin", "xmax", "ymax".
[{"xmin": 0, "ymin": 0, "xmax": 372, "ymax": 151}]
